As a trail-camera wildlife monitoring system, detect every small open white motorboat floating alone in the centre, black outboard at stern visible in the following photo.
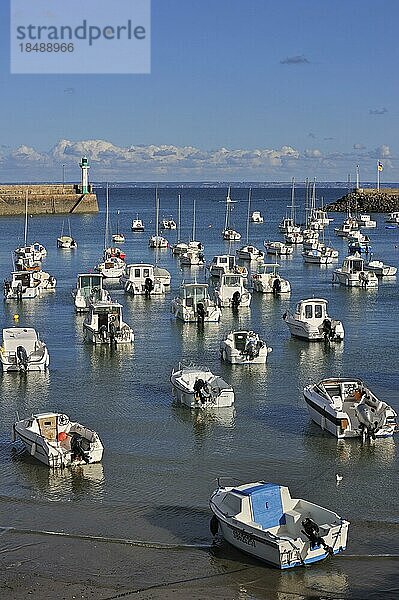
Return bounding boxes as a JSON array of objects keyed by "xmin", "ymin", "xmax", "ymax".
[{"xmin": 170, "ymin": 364, "xmax": 234, "ymax": 409}]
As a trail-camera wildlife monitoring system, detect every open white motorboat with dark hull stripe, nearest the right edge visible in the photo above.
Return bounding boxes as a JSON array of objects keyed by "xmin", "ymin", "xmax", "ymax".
[{"xmin": 303, "ymin": 377, "xmax": 397, "ymax": 439}]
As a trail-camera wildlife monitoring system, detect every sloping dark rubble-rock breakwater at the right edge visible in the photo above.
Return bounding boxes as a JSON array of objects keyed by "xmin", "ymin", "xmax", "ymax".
[{"xmin": 326, "ymin": 188, "xmax": 399, "ymax": 213}]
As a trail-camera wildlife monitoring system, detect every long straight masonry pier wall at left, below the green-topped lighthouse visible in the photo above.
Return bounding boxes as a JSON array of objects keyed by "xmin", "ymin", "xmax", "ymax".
[{"xmin": 0, "ymin": 184, "xmax": 98, "ymax": 216}]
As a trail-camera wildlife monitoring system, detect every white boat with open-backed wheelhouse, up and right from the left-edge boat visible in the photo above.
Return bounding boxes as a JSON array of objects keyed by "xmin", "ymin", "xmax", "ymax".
[{"xmin": 83, "ymin": 301, "xmax": 134, "ymax": 346}]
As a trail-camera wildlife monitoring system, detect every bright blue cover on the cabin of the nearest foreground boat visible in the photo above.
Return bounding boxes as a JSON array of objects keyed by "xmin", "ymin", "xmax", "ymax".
[{"xmin": 234, "ymin": 483, "xmax": 285, "ymax": 529}]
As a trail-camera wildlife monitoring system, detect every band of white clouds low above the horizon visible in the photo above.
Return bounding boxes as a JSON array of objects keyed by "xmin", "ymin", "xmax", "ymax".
[{"xmin": 0, "ymin": 140, "xmax": 393, "ymax": 182}]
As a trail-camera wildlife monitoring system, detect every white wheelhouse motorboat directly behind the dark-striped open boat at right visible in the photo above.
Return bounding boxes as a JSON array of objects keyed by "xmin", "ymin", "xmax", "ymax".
[{"xmin": 283, "ymin": 298, "xmax": 344, "ymax": 341}]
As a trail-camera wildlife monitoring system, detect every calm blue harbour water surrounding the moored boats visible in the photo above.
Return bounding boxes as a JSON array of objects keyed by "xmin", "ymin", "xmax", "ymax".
[{"xmin": 0, "ymin": 187, "xmax": 399, "ymax": 599}]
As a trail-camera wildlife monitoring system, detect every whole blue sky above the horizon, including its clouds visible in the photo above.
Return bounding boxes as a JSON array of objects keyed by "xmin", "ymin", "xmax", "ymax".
[{"xmin": 0, "ymin": 0, "xmax": 399, "ymax": 181}]
